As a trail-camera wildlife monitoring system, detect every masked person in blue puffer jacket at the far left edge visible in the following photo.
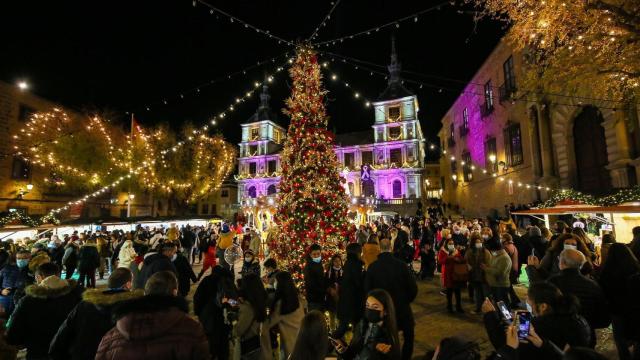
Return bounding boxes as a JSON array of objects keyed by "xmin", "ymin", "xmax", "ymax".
[{"xmin": 0, "ymin": 250, "xmax": 34, "ymax": 316}]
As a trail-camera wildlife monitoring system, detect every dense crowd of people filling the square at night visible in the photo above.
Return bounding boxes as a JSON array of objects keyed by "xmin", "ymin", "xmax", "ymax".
[{"xmin": 0, "ymin": 211, "xmax": 640, "ymax": 360}]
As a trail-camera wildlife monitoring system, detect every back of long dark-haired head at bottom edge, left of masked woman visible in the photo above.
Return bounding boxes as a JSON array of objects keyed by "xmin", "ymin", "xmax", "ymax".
[{"xmin": 289, "ymin": 310, "xmax": 329, "ymax": 360}]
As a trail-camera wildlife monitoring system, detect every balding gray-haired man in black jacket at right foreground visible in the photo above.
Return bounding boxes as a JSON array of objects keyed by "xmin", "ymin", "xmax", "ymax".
[{"xmin": 547, "ymin": 249, "xmax": 611, "ymax": 346}]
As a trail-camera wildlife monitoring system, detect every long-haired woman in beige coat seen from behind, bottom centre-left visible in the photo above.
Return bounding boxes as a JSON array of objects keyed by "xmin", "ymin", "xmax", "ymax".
[{"xmin": 261, "ymin": 271, "xmax": 304, "ymax": 360}]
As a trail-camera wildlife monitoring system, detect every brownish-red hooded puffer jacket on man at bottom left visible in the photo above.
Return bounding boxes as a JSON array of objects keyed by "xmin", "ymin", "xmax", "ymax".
[{"xmin": 95, "ymin": 295, "xmax": 211, "ymax": 360}]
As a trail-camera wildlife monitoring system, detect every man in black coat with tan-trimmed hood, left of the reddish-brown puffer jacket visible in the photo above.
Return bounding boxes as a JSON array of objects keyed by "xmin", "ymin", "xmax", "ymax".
[{"xmin": 49, "ymin": 268, "xmax": 144, "ymax": 360}]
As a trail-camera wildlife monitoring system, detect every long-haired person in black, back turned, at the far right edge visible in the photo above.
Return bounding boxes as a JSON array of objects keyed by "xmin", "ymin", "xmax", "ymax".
[{"xmin": 600, "ymin": 243, "xmax": 640, "ymax": 360}]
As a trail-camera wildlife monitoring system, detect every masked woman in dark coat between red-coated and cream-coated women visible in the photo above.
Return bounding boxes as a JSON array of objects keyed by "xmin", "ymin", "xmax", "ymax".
[{"xmin": 465, "ymin": 232, "xmax": 491, "ymax": 314}]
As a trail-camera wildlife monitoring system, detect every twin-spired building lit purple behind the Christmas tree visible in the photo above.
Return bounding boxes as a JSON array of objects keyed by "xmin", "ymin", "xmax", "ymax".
[{"xmin": 236, "ymin": 40, "xmax": 425, "ymax": 225}]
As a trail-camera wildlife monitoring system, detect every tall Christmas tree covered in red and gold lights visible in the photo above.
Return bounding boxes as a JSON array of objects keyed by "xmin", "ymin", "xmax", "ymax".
[{"xmin": 271, "ymin": 46, "xmax": 348, "ymax": 282}]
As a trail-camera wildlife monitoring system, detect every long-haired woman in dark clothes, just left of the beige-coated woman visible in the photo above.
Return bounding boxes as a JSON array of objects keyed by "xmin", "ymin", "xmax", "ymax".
[{"xmin": 227, "ymin": 273, "xmax": 267, "ymax": 360}]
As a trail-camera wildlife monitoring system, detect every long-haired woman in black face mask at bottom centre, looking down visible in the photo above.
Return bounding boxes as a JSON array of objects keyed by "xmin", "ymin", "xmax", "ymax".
[{"xmin": 334, "ymin": 289, "xmax": 401, "ymax": 360}]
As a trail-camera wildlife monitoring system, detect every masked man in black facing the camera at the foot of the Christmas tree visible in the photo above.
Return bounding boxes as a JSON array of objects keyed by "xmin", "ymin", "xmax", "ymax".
[{"xmin": 303, "ymin": 244, "xmax": 328, "ymax": 311}]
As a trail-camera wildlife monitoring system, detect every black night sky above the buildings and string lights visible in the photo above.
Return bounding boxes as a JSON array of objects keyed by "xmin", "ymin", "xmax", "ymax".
[{"xmin": 0, "ymin": 0, "xmax": 503, "ymax": 143}]
